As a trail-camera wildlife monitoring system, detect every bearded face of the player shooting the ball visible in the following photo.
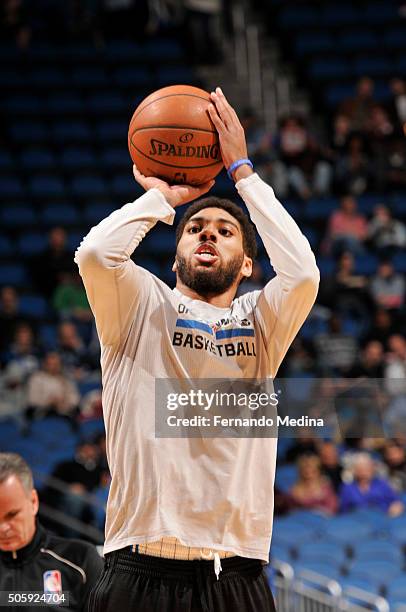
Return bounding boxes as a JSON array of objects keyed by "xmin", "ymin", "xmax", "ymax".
[{"xmin": 174, "ymin": 208, "xmax": 252, "ymax": 296}]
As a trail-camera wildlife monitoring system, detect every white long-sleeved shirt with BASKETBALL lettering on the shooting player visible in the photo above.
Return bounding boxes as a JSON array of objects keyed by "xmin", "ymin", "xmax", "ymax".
[{"xmin": 75, "ymin": 174, "xmax": 319, "ymax": 561}]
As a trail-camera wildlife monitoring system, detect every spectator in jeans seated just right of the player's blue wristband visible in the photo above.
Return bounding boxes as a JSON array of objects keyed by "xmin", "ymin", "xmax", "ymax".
[{"xmin": 273, "ymin": 116, "xmax": 332, "ymax": 200}]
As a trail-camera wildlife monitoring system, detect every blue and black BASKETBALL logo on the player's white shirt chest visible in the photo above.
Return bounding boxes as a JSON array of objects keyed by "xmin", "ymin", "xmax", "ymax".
[{"xmin": 172, "ymin": 311, "xmax": 256, "ymax": 357}]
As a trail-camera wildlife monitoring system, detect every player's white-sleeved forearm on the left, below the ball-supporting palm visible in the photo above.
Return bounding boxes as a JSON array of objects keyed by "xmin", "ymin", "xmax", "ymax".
[{"xmin": 75, "ymin": 189, "xmax": 175, "ymax": 268}]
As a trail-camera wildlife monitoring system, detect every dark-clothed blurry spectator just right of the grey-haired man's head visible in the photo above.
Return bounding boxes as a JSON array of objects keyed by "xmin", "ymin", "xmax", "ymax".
[{"xmin": 51, "ymin": 441, "xmax": 102, "ymax": 537}]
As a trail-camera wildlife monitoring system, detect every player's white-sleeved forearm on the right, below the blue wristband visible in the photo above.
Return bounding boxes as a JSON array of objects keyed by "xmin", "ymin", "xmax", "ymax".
[{"xmin": 236, "ymin": 174, "xmax": 319, "ymax": 289}]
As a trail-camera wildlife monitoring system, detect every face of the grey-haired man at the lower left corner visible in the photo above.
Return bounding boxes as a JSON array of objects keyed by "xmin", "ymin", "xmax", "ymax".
[{"xmin": 0, "ymin": 475, "xmax": 38, "ymax": 551}]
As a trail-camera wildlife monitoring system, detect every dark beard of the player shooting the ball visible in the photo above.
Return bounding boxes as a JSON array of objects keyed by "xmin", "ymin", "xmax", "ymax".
[{"xmin": 176, "ymin": 253, "xmax": 244, "ymax": 297}]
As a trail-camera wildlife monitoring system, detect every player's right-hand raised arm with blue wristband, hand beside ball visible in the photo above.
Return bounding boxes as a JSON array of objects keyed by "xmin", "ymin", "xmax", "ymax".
[{"xmin": 209, "ymin": 88, "xmax": 320, "ymax": 376}]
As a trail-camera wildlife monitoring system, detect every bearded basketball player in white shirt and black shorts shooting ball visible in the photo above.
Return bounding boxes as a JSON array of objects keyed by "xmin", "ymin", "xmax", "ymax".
[{"xmin": 75, "ymin": 88, "xmax": 319, "ymax": 612}]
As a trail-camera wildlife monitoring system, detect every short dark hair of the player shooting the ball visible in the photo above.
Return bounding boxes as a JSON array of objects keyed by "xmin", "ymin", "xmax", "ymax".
[{"xmin": 176, "ymin": 196, "xmax": 257, "ymax": 261}]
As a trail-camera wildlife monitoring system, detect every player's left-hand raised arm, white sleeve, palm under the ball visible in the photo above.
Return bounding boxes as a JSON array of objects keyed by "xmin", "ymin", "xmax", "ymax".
[{"xmin": 75, "ymin": 177, "xmax": 212, "ymax": 345}]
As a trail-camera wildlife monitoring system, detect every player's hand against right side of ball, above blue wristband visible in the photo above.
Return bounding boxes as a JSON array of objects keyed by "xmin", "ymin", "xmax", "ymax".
[{"xmin": 209, "ymin": 87, "xmax": 252, "ymax": 180}]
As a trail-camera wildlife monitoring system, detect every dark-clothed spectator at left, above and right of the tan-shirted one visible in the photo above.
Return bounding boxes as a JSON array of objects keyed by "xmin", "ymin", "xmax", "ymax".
[{"xmin": 57, "ymin": 321, "xmax": 87, "ymax": 380}]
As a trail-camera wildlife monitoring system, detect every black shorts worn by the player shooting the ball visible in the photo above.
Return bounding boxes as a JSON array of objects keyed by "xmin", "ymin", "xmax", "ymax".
[{"xmin": 88, "ymin": 547, "xmax": 275, "ymax": 612}]
